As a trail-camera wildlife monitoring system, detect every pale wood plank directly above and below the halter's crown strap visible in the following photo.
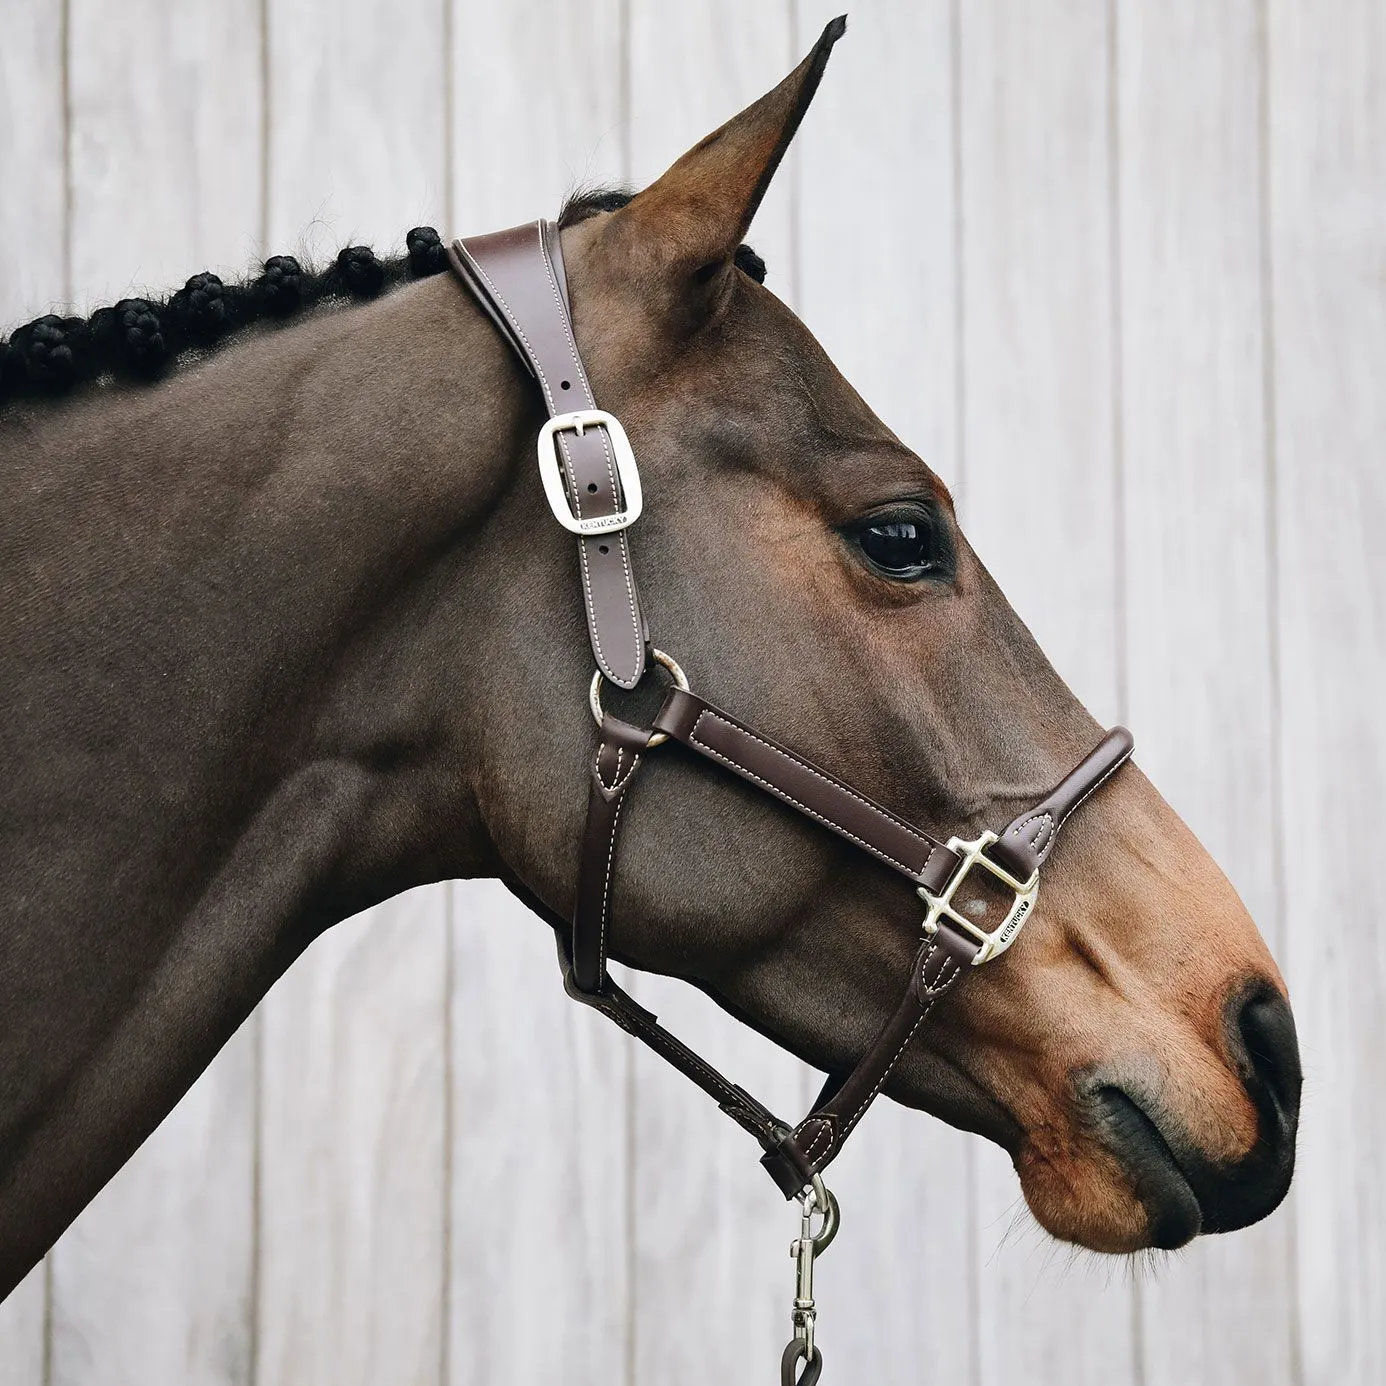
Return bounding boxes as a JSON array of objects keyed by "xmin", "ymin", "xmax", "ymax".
[{"xmin": 446, "ymin": 0, "xmax": 633, "ymax": 1386}]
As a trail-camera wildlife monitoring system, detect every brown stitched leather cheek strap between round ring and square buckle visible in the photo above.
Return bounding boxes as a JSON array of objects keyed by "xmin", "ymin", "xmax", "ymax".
[{"xmin": 654, "ymin": 689, "xmax": 959, "ymax": 891}]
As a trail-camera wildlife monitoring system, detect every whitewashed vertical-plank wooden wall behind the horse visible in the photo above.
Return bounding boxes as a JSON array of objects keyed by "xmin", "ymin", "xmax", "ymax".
[{"xmin": 0, "ymin": 0, "xmax": 1386, "ymax": 1386}]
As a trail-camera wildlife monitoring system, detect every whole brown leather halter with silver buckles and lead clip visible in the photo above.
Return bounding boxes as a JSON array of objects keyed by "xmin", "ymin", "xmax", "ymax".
[{"xmin": 449, "ymin": 222, "xmax": 1132, "ymax": 1386}]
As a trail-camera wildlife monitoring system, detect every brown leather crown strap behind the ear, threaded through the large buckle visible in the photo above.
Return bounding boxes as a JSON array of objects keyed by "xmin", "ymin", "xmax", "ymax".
[{"xmin": 448, "ymin": 222, "xmax": 649, "ymax": 689}]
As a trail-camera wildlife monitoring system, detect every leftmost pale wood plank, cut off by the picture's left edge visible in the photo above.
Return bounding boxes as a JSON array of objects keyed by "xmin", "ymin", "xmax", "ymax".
[{"xmin": 0, "ymin": 0, "xmax": 68, "ymax": 1386}]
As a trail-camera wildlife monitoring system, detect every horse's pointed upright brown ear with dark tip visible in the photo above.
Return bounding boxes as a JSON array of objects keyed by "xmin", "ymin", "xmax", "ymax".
[{"xmin": 606, "ymin": 15, "xmax": 847, "ymax": 317}]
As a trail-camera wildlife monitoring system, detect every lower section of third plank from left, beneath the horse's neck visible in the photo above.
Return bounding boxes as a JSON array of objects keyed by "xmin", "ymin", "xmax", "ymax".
[{"xmin": 254, "ymin": 887, "xmax": 446, "ymax": 1386}]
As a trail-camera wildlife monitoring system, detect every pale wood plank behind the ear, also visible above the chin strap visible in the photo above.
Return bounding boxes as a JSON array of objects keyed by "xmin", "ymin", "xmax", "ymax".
[{"xmin": 628, "ymin": 0, "xmax": 807, "ymax": 1386}]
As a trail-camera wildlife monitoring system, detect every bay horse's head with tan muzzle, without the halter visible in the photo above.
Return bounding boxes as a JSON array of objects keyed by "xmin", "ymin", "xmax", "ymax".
[{"xmin": 465, "ymin": 28, "xmax": 1300, "ymax": 1252}]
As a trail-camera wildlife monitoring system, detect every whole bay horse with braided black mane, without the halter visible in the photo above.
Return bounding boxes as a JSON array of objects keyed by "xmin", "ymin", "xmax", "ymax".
[{"xmin": 0, "ymin": 16, "xmax": 1300, "ymax": 1319}]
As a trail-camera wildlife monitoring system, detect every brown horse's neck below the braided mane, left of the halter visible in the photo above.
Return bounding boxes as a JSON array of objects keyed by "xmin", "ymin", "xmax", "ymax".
[{"xmin": 0, "ymin": 270, "xmax": 525, "ymax": 1295}]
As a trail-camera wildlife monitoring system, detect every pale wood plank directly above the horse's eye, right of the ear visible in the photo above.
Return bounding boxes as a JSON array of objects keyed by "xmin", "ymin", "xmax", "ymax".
[{"xmin": 792, "ymin": 0, "xmax": 976, "ymax": 1383}]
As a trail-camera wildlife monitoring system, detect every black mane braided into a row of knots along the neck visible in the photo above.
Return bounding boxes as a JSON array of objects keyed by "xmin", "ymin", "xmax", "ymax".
[{"xmin": 0, "ymin": 226, "xmax": 448, "ymax": 406}]
